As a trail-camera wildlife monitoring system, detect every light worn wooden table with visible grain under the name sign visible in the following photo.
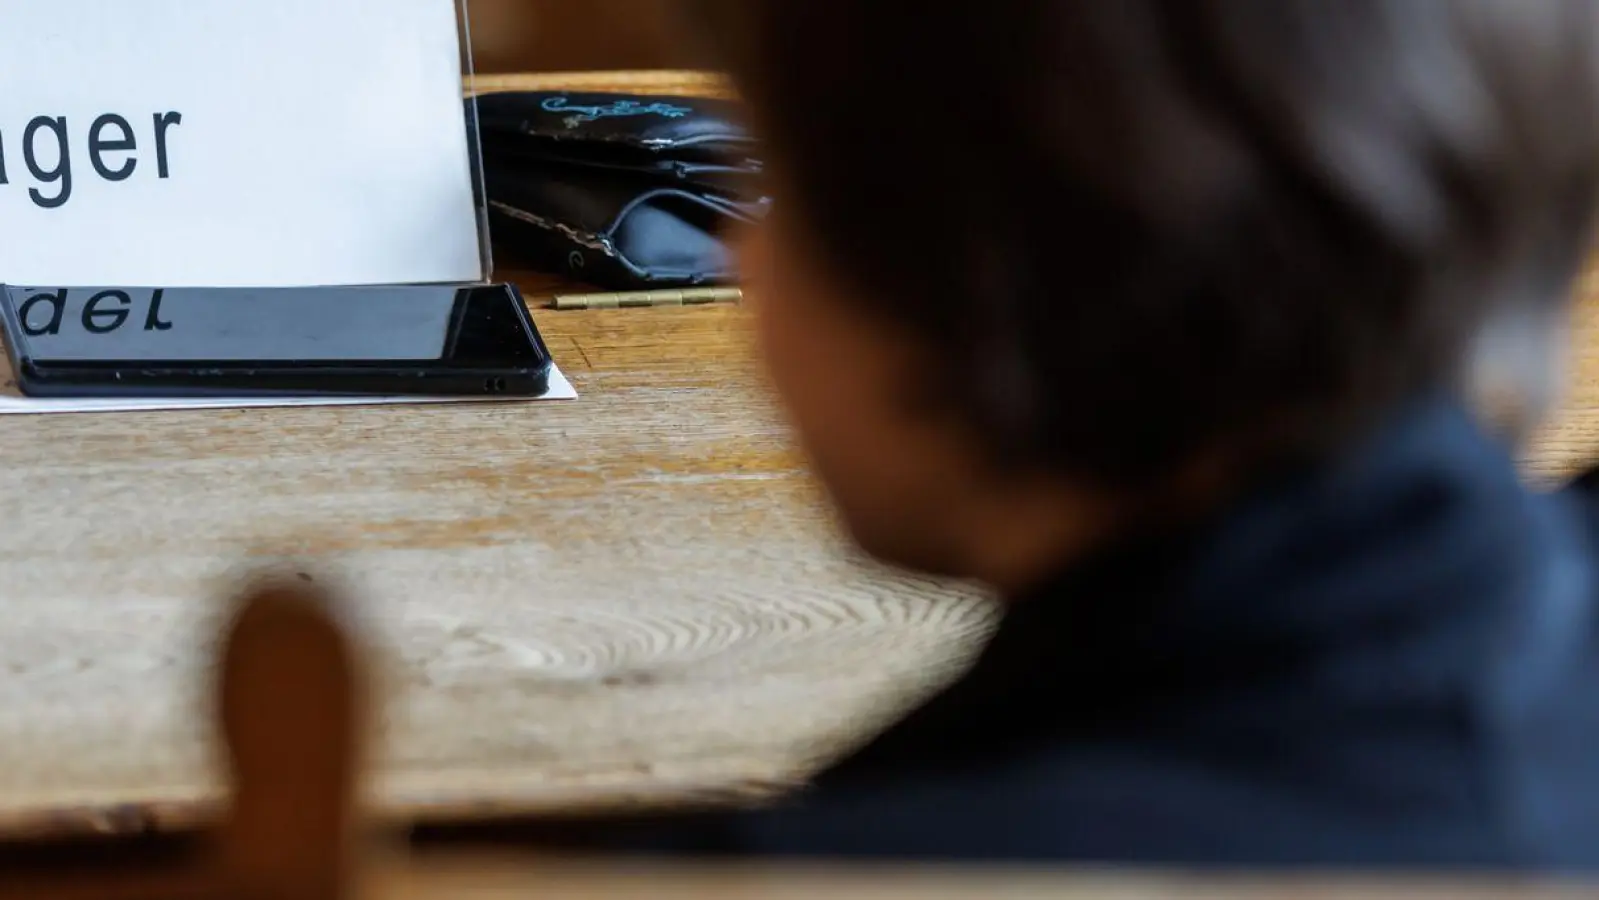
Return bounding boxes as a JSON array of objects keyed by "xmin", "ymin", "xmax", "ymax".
[{"xmin": 0, "ymin": 74, "xmax": 1599, "ymax": 834}]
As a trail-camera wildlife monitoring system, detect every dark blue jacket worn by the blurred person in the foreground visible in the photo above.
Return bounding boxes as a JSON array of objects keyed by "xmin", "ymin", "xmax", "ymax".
[{"xmin": 518, "ymin": 403, "xmax": 1599, "ymax": 873}]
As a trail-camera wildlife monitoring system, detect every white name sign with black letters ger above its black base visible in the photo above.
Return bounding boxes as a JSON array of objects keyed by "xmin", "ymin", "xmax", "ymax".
[{"xmin": 0, "ymin": 0, "xmax": 486, "ymax": 288}]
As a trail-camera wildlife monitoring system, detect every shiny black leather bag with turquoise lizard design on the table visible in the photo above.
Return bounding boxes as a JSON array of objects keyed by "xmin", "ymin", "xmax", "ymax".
[{"xmin": 469, "ymin": 91, "xmax": 768, "ymax": 291}]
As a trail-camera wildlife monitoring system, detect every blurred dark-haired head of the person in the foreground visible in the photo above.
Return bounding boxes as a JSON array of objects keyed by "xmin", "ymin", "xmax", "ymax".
[{"xmin": 690, "ymin": 0, "xmax": 1599, "ymax": 588}]
